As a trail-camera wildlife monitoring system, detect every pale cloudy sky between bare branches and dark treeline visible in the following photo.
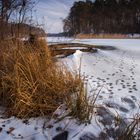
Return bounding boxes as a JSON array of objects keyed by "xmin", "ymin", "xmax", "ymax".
[{"xmin": 36, "ymin": 0, "xmax": 78, "ymax": 33}]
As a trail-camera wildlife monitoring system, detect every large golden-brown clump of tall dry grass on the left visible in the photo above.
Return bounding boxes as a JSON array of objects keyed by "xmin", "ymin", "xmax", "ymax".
[{"xmin": 0, "ymin": 40, "xmax": 94, "ymax": 120}]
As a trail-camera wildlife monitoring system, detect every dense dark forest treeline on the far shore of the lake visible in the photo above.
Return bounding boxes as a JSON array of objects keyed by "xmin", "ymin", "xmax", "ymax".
[{"xmin": 64, "ymin": 0, "xmax": 140, "ymax": 35}]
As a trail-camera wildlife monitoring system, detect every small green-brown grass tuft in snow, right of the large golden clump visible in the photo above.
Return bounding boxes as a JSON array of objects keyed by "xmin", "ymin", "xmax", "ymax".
[{"xmin": 64, "ymin": 83, "xmax": 95, "ymax": 124}]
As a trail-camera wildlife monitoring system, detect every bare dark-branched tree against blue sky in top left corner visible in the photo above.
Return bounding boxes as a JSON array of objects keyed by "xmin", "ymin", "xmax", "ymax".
[{"xmin": 0, "ymin": 0, "xmax": 36, "ymax": 38}]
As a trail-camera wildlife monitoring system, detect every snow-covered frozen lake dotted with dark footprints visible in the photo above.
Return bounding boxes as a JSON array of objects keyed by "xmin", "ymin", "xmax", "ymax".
[{"xmin": 64, "ymin": 39, "xmax": 140, "ymax": 117}]
